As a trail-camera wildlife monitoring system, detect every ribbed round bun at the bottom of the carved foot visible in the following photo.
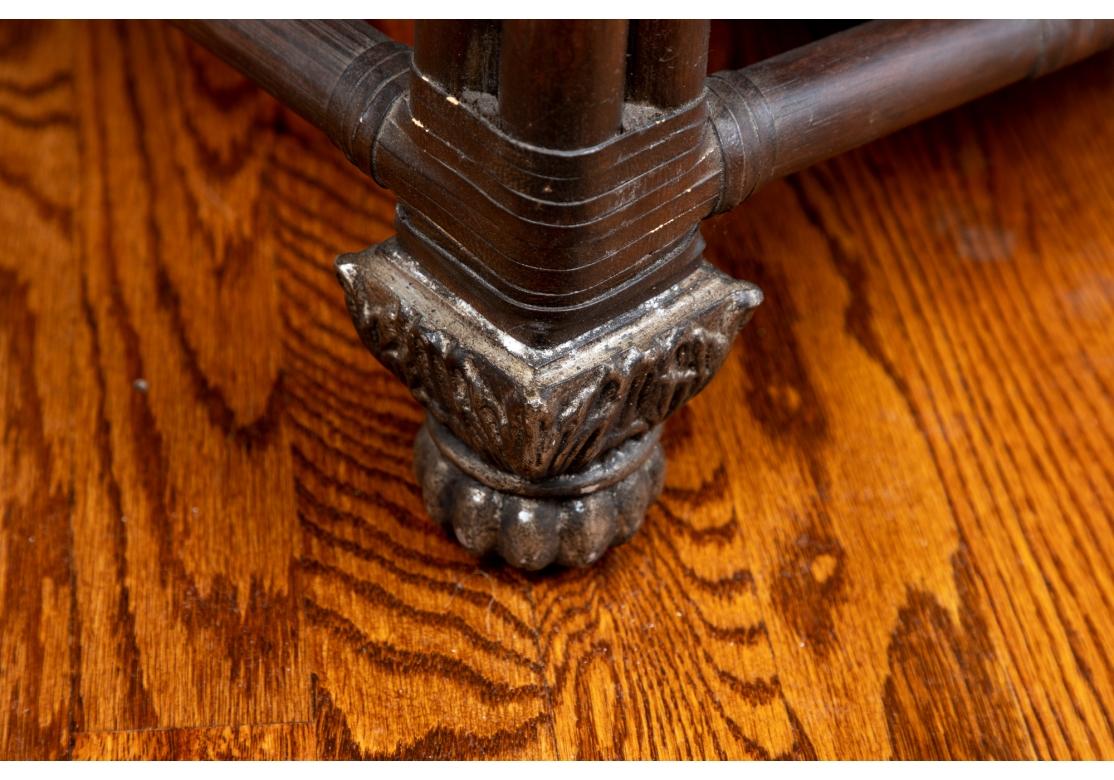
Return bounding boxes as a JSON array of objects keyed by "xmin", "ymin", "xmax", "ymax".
[{"xmin": 414, "ymin": 420, "xmax": 665, "ymax": 569}]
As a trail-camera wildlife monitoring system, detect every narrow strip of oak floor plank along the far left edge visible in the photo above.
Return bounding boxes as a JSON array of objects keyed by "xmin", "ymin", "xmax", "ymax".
[{"xmin": 0, "ymin": 23, "xmax": 80, "ymax": 758}]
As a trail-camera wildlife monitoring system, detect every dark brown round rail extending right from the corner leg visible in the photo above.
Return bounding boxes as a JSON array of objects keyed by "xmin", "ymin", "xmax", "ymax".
[{"xmin": 705, "ymin": 20, "xmax": 1114, "ymax": 211}]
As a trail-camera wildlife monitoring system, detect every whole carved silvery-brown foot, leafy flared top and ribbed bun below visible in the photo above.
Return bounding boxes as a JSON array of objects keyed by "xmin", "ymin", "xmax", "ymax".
[{"xmin": 336, "ymin": 240, "xmax": 762, "ymax": 568}]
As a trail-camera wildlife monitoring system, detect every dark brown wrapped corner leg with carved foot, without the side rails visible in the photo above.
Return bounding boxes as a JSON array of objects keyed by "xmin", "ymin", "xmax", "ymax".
[{"xmin": 338, "ymin": 21, "xmax": 761, "ymax": 568}]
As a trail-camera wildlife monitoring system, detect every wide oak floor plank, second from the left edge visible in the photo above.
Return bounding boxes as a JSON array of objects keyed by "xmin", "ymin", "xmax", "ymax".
[{"xmin": 74, "ymin": 23, "xmax": 312, "ymax": 730}]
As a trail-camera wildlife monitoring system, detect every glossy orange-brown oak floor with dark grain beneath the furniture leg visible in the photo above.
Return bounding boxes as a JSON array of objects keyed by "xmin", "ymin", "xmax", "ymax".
[{"xmin": 0, "ymin": 23, "xmax": 1114, "ymax": 758}]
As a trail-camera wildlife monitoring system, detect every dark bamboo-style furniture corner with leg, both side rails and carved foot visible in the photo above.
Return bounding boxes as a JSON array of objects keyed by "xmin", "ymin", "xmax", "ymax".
[{"xmin": 180, "ymin": 21, "xmax": 1114, "ymax": 568}]
